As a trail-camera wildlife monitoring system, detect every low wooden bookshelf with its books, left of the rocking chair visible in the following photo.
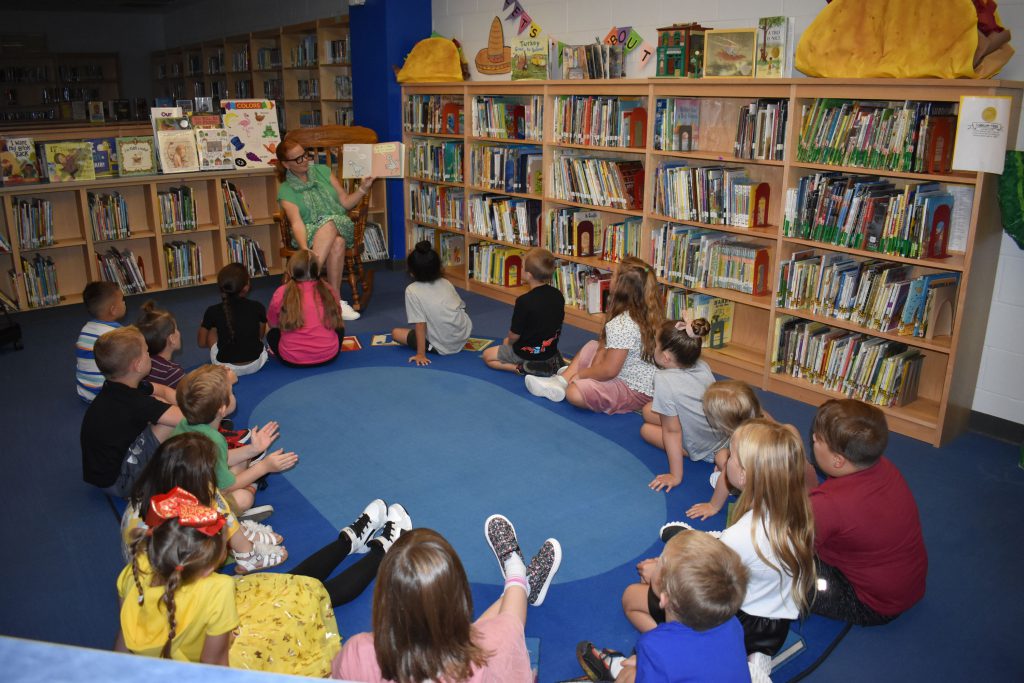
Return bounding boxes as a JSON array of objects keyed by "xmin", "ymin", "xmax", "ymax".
[{"xmin": 0, "ymin": 123, "xmax": 281, "ymax": 309}]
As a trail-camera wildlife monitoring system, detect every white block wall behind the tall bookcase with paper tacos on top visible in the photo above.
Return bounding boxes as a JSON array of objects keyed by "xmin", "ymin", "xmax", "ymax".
[{"xmin": 431, "ymin": 0, "xmax": 1024, "ymax": 423}]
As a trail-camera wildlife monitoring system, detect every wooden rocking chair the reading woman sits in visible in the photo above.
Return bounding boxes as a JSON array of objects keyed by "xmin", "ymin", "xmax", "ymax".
[{"xmin": 273, "ymin": 126, "xmax": 377, "ymax": 310}]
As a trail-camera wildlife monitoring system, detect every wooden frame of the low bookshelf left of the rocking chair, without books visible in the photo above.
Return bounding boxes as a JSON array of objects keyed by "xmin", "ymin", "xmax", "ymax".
[{"xmin": 0, "ymin": 124, "xmax": 282, "ymax": 310}]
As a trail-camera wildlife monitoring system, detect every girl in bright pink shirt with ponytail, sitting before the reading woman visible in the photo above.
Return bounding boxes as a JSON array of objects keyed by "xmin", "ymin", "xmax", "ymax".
[{"xmin": 266, "ymin": 250, "xmax": 345, "ymax": 367}]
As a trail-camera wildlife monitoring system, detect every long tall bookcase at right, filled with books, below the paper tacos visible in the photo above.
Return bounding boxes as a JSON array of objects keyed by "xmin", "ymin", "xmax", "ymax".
[{"xmin": 402, "ymin": 79, "xmax": 1022, "ymax": 444}]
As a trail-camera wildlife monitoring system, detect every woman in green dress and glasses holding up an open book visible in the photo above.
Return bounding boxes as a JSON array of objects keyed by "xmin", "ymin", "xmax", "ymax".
[{"xmin": 276, "ymin": 139, "xmax": 374, "ymax": 321}]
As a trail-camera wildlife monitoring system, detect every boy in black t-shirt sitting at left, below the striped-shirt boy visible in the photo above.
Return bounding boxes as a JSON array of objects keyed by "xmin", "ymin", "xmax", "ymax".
[{"xmin": 81, "ymin": 327, "xmax": 182, "ymax": 498}]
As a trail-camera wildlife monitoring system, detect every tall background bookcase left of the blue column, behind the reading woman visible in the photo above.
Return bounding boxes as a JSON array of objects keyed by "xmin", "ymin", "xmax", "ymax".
[{"xmin": 151, "ymin": 16, "xmax": 353, "ymax": 132}]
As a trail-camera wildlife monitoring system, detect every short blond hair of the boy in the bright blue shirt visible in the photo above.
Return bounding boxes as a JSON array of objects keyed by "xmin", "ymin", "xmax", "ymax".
[{"xmin": 658, "ymin": 529, "xmax": 750, "ymax": 631}]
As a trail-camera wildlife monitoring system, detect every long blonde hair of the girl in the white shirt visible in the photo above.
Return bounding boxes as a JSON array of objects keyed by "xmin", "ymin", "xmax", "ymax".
[{"xmin": 730, "ymin": 418, "xmax": 814, "ymax": 612}]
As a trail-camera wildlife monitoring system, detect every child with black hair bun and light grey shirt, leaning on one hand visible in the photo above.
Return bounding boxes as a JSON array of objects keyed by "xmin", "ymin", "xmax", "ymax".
[{"xmin": 391, "ymin": 241, "xmax": 473, "ymax": 366}]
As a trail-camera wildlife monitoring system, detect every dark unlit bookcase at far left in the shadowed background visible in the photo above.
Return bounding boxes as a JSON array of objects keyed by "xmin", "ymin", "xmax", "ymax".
[{"xmin": 0, "ymin": 50, "xmax": 121, "ymax": 126}]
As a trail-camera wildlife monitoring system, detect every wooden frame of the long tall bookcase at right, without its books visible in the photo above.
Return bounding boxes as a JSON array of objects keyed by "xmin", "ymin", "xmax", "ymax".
[{"xmin": 402, "ymin": 79, "xmax": 1024, "ymax": 445}]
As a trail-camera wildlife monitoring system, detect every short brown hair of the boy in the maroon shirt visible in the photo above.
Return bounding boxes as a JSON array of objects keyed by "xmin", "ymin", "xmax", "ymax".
[{"xmin": 811, "ymin": 398, "xmax": 889, "ymax": 467}]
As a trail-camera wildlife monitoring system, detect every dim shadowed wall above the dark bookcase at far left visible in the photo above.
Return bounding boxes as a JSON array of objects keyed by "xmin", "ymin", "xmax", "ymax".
[{"xmin": 0, "ymin": 10, "xmax": 164, "ymax": 97}]
